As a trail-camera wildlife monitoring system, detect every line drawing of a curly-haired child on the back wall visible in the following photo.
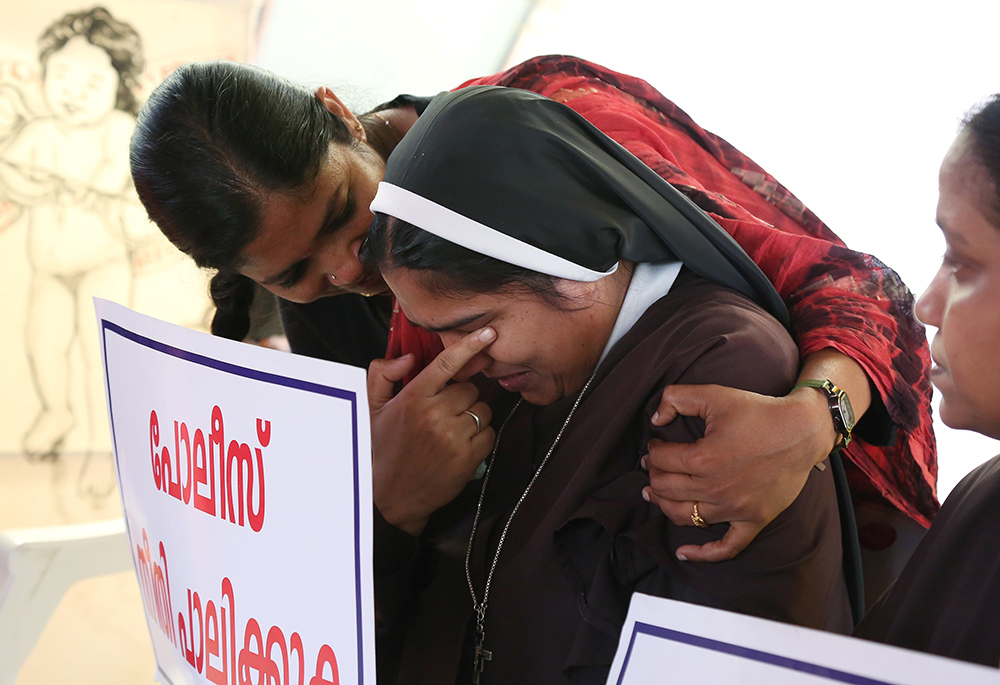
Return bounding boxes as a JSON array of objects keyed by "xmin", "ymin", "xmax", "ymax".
[{"xmin": 0, "ymin": 7, "xmax": 144, "ymax": 494}]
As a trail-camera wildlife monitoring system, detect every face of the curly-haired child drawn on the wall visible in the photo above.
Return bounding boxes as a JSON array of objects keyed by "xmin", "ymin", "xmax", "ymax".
[{"xmin": 43, "ymin": 36, "xmax": 119, "ymax": 126}]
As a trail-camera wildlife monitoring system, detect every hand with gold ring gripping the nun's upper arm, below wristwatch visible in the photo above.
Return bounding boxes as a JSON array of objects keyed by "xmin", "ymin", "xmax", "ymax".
[{"xmin": 643, "ymin": 385, "xmax": 835, "ymax": 561}]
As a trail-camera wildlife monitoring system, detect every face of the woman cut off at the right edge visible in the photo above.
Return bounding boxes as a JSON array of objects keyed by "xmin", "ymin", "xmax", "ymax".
[{"xmin": 915, "ymin": 134, "xmax": 1000, "ymax": 439}]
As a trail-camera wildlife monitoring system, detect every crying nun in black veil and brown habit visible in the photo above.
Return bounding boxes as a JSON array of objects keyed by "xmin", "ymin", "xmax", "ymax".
[{"xmin": 363, "ymin": 86, "xmax": 852, "ymax": 685}]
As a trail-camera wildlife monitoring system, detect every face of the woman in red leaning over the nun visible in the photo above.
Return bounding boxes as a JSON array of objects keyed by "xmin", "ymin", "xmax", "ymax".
[{"xmin": 240, "ymin": 144, "xmax": 386, "ymax": 302}]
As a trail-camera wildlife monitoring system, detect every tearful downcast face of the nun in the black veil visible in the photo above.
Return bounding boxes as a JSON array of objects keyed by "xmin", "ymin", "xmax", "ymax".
[{"xmin": 385, "ymin": 269, "xmax": 628, "ymax": 405}]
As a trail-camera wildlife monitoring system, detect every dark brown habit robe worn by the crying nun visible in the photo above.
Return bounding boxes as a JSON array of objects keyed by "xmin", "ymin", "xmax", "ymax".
[{"xmin": 376, "ymin": 271, "xmax": 851, "ymax": 685}]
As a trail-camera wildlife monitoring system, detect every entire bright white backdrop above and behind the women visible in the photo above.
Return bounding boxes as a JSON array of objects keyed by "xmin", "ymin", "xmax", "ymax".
[{"xmin": 258, "ymin": 0, "xmax": 1000, "ymax": 496}]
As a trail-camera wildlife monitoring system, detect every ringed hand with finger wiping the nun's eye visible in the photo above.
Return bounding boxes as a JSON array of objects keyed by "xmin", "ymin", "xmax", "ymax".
[{"xmin": 368, "ymin": 328, "xmax": 496, "ymax": 535}]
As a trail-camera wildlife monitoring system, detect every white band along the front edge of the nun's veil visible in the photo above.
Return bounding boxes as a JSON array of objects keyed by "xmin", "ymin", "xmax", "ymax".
[{"xmin": 371, "ymin": 181, "xmax": 618, "ymax": 281}]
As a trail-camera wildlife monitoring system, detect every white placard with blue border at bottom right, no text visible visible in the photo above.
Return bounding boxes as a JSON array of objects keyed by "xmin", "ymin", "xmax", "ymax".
[{"xmin": 608, "ymin": 593, "xmax": 1000, "ymax": 685}]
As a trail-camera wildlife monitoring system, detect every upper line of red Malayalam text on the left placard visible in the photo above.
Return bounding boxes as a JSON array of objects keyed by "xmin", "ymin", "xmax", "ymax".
[{"xmin": 149, "ymin": 406, "xmax": 271, "ymax": 532}]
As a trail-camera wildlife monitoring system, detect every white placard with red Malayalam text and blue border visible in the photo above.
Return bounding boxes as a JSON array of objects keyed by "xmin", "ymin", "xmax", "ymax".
[{"xmin": 95, "ymin": 300, "xmax": 375, "ymax": 685}]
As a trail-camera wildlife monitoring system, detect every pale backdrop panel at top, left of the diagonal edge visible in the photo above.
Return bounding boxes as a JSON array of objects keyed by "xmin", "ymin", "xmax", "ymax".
[{"xmin": 257, "ymin": 0, "xmax": 532, "ymax": 110}]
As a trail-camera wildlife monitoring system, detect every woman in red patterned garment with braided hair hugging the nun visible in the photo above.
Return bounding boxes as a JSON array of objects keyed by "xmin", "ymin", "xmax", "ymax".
[{"xmin": 132, "ymin": 56, "xmax": 937, "ymax": 560}]
